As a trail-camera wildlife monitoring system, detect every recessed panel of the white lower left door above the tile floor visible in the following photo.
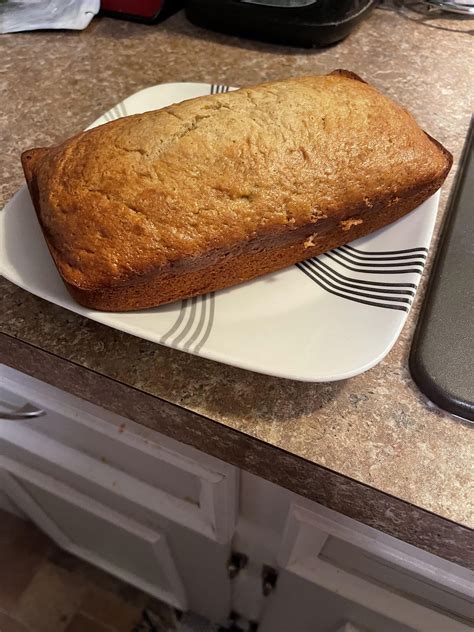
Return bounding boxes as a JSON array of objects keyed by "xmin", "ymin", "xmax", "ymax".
[{"xmin": 0, "ymin": 463, "xmax": 187, "ymax": 609}]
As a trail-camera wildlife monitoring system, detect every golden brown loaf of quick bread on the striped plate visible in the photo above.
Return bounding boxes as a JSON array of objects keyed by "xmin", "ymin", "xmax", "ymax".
[{"xmin": 22, "ymin": 71, "xmax": 452, "ymax": 311}]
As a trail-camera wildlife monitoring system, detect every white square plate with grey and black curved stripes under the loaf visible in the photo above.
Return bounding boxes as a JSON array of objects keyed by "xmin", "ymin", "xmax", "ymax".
[{"xmin": 0, "ymin": 83, "xmax": 439, "ymax": 382}]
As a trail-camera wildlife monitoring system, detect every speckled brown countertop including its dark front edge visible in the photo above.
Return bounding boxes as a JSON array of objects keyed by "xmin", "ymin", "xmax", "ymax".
[{"xmin": 0, "ymin": 8, "xmax": 474, "ymax": 566}]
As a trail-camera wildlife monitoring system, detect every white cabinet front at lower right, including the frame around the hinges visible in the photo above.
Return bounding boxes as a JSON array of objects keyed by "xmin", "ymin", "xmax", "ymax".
[{"xmin": 234, "ymin": 472, "xmax": 474, "ymax": 632}]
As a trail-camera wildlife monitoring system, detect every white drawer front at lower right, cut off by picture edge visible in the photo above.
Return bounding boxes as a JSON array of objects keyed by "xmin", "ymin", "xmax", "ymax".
[{"xmin": 279, "ymin": 504, "xmax": 473, "ymax": 632}]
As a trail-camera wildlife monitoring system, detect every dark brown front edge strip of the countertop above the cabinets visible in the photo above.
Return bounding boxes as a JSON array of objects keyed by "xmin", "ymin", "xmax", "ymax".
[{"xmin": 0, "ymin": 332, "xmax": 474, "ymax": 568}]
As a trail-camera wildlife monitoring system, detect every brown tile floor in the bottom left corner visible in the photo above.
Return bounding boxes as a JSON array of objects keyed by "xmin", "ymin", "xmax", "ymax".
[{"xmin": 0, "ymin": 510, "xmax": 222, "ymax": 632}]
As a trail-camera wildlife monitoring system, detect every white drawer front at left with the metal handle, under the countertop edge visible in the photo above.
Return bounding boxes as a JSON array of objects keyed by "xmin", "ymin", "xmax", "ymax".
[{"xmin": 0, "ymin": 366, "xmax": 237, "ymax": 542}]
